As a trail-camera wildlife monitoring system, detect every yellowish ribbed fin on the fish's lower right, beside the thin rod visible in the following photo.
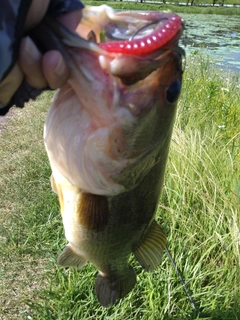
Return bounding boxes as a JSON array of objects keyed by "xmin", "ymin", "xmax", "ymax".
[{"xmin": 133, "ymin": 220, "xmax": 166, "ymax": 271}]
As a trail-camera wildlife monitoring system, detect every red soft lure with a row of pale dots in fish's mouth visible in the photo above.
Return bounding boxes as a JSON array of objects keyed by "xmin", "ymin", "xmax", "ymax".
[{"xmin": 99, "ymin": 12, "xmax": 183, "ymax": 55}]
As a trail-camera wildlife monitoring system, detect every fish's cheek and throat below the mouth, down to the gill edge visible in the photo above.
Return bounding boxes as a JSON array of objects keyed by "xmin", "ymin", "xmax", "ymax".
[{"xmin": 44, "ymin": 47, "xmax": 182, "ymax": 196}]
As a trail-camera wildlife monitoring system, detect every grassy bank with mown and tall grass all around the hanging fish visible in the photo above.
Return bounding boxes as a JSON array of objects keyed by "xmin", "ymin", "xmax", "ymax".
[{"xmin": 0, "ymin": 55, "xmax": 240, "ymax": 320}]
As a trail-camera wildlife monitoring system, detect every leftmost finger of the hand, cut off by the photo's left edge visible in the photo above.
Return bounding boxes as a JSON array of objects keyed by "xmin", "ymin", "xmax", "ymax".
[{"xmin": 0, "ymin": 64, "xmax": 23, "ymax": 104}]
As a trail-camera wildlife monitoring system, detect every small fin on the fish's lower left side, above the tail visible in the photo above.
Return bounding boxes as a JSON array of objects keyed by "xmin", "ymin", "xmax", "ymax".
[{"xmin": 58, "ymin": 245, "xmax": 87, "ymax": 269}]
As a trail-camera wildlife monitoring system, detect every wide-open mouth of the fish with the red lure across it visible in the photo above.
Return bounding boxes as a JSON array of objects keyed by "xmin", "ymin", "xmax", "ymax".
[{"xmin": 37, "ymin": 5, "xmax": 184, "ymax": 61}]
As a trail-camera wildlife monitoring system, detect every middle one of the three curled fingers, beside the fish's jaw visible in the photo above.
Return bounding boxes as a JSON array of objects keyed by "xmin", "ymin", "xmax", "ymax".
[{"xmin": 19, "ymin": 37, "xmax": 47, "ymax": 88}]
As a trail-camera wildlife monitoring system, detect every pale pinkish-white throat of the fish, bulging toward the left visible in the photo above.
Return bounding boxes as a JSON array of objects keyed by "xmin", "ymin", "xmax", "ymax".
[{"xmin": 44, "ymin": 52, "xmax": 126, "ymax": 195}]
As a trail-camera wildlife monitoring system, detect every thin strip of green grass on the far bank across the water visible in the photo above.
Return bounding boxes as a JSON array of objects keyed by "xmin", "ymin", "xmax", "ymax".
[{"xmin": 84, "ymin": 0, "xmax": 240, "ymax": 15}]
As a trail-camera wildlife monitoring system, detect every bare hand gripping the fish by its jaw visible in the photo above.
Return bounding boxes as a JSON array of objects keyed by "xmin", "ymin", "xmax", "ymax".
[{"xmin": 0, "ymin": 0, "xmax": 82, "ymax": 104}]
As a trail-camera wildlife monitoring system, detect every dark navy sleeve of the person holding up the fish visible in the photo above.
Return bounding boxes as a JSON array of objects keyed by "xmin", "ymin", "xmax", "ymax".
[{"xmin": 0, "ymin": 0, "xmax": 84, "ymax": 115}]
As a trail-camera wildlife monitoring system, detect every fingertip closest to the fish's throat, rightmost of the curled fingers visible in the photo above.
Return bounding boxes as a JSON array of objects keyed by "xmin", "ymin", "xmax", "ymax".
[{"xmin": 42, "ymin": 50, "xmax": 69, "ymax": 89}]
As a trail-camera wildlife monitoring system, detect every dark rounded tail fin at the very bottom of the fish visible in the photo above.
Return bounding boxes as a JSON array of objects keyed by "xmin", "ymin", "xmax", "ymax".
[{"xmin": 95, "ymin": 266, "xmax": 136, "ymax": 307}]
